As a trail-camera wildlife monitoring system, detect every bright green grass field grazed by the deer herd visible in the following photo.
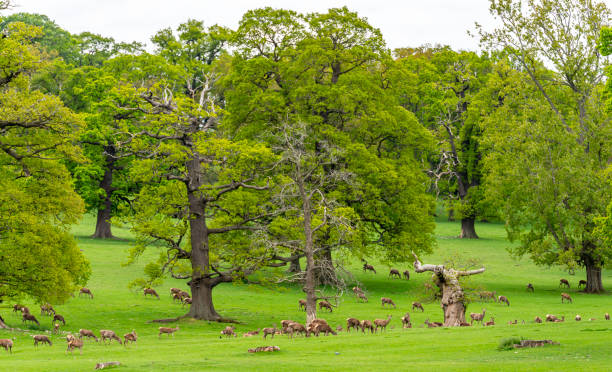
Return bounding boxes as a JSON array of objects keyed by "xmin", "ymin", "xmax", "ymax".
[{"xmin": 0, "ymin": 217, "xmax": 612, "ymax": 371}]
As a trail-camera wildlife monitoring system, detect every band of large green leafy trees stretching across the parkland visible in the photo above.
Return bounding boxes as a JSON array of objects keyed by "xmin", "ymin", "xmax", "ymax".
[{"xmin": 0, "ymin": 0, "xmax": 612, "ymax": 321}]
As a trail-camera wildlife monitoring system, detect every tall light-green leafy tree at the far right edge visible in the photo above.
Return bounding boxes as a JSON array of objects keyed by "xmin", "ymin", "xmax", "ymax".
[{"xmin": 480, "ymin": 0, "xmax": 612, "ymax": 293}]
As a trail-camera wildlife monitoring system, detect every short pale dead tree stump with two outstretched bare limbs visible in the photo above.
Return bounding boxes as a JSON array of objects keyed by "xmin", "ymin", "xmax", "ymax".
[{"xmin": 412, "ymin": 252, "xmax": 485, "ymax": 327}]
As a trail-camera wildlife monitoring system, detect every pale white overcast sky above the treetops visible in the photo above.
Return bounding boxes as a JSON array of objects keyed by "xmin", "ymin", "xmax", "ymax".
[{"xmin": 7, "ymin": 0, "xmax": 502, "ymax": 50}]
